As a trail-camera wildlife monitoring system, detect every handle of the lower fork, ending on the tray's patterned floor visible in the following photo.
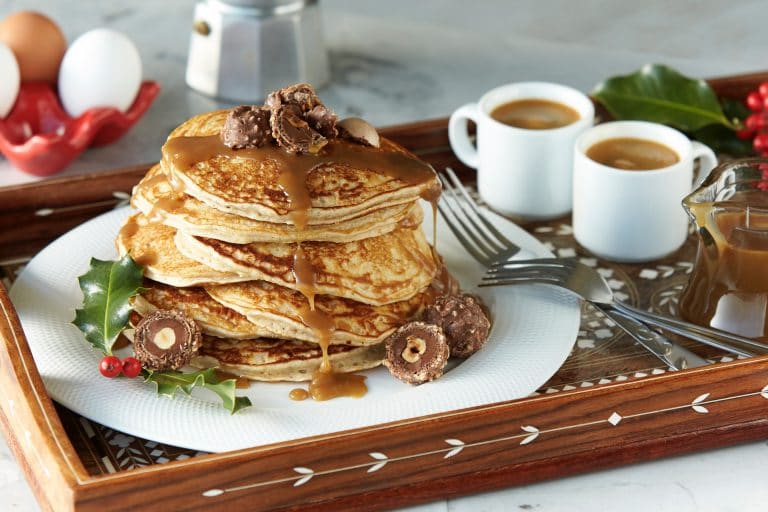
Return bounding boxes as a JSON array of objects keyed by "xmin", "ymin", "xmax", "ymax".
[{"xmin": 592, "ymin": 303, "xmax": 710, "ymax": 370}]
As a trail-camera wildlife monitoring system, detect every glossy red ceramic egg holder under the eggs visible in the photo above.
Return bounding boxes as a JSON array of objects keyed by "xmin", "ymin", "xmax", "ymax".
[{"xmin": 0, "ymin": 81, "xmax": 160, "ymax": 176}]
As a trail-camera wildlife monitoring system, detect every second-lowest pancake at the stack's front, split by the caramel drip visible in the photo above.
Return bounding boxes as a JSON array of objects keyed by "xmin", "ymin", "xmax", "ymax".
[{"xmin": 205, "ymin": 281, "xmax": 432, "ymax": 345}]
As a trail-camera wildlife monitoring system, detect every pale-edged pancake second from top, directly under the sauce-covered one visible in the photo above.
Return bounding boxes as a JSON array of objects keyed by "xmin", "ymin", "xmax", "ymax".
[{"xmin": 131, "ymin": 165, "xmax": 423, "ymax": 244}]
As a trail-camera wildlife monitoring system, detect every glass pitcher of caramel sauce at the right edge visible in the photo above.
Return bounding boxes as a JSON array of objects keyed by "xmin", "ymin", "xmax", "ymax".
[{"xmin": 680, "ymin": 202, "xmax": 768, "ymax": 341}]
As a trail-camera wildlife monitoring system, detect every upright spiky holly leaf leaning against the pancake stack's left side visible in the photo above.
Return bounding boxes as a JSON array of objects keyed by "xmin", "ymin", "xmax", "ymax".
[{"xmin": 72, "ymin": 255, "xmax": 144, "ymax": 354}]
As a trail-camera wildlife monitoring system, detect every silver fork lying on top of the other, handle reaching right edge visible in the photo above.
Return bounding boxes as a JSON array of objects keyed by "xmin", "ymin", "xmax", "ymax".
[{"xmin": 480, "ymin": 258, "xmax": 768, "ymax": 356}]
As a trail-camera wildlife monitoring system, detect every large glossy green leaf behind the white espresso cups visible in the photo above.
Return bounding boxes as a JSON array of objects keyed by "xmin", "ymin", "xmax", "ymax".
[{"xmin": 592, "ymin": 64, "xmax": 738, "ymax": 132}]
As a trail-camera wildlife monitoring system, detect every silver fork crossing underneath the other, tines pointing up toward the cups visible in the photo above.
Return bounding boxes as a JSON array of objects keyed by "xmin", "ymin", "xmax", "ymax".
[{"xmin": 437, "ymin": 168, "xmax": 709, "ymax": 370}]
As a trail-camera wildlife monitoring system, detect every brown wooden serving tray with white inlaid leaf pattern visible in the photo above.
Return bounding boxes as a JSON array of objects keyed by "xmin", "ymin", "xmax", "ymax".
[{"xmin": 0, "ymin": 73, "xmax": 768, "ymax": 510}]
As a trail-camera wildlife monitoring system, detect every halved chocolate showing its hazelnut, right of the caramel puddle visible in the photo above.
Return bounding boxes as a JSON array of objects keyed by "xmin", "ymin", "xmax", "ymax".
[{"xmin": 383, "ymin": 322, "xmax": 450, "ymax": 384}]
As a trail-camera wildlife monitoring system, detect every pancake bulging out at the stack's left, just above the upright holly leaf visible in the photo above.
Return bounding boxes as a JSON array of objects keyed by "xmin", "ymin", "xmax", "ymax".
[{"xmin": 116, "ymin": 213, "xmax": 247, "ymax": 286}]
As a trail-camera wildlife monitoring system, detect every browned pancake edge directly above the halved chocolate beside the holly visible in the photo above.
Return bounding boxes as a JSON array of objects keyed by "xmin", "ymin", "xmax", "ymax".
[{"xmin": 132, "ymin": 279, "xmax": 274, "ymax": 339}]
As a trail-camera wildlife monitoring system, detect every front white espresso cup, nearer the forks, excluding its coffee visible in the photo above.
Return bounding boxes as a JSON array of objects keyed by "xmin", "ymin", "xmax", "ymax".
[{"xmin": 573, "ymin": 121, "xmax": 717, "ymax": 262}]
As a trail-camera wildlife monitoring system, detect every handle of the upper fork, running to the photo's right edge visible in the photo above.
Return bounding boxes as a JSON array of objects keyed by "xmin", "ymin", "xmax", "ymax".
[{"xmin": 613, "ymin": 301, "xmax": 768, "ymax": 357}]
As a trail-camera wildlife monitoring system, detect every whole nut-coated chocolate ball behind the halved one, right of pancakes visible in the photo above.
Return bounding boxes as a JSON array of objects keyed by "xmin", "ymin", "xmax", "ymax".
[{"xmin": 423, "ymin": 294, "xmax": 491, "ymax": 357}]
